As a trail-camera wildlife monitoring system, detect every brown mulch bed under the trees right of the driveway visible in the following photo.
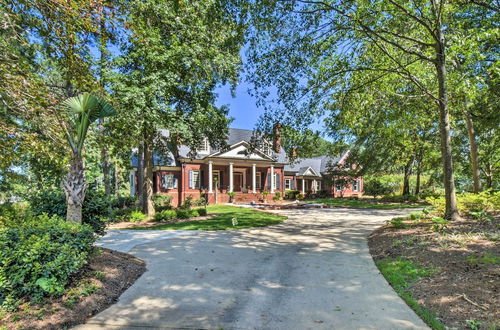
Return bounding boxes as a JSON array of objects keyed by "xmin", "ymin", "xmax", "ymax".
[{"xmin": 368, "ymin": 214, "xmax": 500, "ymax": 329}]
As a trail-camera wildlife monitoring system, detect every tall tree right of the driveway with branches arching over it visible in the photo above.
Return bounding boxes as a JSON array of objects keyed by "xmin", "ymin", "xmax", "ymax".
[{"xmin": 249, "ymin": 0, "xmax": 496, "ymax": 219}]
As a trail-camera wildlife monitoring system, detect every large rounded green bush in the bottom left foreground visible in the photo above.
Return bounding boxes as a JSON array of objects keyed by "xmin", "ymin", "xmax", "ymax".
[{"xmin": 0, "ymin": 214, "xmax": 96, "ymax": 308}]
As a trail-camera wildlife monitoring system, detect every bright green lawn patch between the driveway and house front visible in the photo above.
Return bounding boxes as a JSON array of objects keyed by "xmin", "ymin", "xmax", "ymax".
[{"xmin": 134, "ymin": 205, "xmax": 286, "ymax": 230}]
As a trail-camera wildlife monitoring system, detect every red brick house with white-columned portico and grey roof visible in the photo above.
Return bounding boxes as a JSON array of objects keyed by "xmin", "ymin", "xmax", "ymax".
[{"xmin": 130, "ymin": 128, "xmax": 363, "ymax": 206}]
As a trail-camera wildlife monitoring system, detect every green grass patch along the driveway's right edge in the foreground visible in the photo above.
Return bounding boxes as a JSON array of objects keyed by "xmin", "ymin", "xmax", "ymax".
[{"xmin": 375, "ymin": 258, "xmax": 446, "ymax": 330}]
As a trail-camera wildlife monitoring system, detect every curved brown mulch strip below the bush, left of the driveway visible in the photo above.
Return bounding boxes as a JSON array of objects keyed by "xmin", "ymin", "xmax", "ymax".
[{"xmin": 0, "ymin": 248, "xmax": 146, "ymax": 329}]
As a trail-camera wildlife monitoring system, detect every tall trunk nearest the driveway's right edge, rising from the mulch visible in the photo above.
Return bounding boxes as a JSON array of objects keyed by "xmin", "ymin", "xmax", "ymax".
[{"xmin": 436, "ymin": 29, "xmax": 459, "ymax": 220}]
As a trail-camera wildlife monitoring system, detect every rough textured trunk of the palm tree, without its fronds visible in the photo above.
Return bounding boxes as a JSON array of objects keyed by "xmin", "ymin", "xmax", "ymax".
[{"xmin": 63, "ymin": 153, "xmax": 87, "ymax": 223}]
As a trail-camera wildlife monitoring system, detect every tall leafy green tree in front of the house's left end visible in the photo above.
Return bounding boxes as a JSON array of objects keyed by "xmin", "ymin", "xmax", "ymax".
[{"xmin": 112, "ymin": 0, "xmax": 243, "ymax": 216}]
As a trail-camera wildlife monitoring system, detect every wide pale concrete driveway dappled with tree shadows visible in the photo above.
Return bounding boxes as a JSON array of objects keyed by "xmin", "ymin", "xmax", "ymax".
[{"xmin": 77, "ymin": 209, "xmax": 427, "ymax": 329}]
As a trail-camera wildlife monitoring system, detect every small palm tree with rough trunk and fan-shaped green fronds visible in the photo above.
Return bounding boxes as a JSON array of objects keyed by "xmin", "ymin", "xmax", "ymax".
[{"xmin": 62, "ymin": 93, "xmax": 116, "ymax": 223}]
